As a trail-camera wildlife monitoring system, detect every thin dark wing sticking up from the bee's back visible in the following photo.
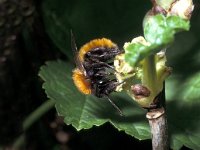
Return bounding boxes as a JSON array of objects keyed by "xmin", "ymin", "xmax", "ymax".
[{"xmin": 70, "ymin": 30, "xmax": 85, "ymax": 72}]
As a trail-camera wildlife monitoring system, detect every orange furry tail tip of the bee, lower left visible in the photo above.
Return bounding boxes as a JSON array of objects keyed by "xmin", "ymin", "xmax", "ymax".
[{"xmin": 72, "ymin": 69, "xmax": 92, "ymax": 95}]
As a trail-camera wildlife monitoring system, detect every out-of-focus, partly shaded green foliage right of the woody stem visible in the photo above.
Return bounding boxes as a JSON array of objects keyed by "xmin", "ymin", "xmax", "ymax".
[{"xmin": 163, "ymin": 20, "xmax": 200, "ymax": 150}]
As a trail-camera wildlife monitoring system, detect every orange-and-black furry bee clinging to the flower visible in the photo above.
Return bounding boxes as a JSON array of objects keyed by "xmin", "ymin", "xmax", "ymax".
[{"xmin": 71, "ymin": 32, "xmax": 123, "ymax": 116}]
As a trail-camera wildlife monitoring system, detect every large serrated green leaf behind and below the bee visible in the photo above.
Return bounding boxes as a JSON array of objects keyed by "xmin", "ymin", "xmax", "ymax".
[{"xmin": 39, "ymin": 61, "xmax": 150, "ymax": 139}]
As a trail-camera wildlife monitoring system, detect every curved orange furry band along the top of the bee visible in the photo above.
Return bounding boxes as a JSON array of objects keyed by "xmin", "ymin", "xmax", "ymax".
[{"xmin": 78, "ymin": 38, "xmax": 116, "ymax": 62}]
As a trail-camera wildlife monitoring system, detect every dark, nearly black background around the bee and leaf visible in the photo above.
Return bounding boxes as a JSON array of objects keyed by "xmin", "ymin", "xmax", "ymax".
[{"xmin": 0, "ymin": 0, "xmax": 200, "ymax": 150}]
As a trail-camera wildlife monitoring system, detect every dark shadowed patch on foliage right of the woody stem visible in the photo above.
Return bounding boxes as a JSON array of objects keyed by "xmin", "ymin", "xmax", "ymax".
[{"xmin": 167, "ymin": 100, "xmax": 200, "ymax": 137}]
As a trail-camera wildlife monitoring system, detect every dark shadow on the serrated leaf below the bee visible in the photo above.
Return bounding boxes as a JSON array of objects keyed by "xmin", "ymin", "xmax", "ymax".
[{"xmin": 93, "ymin": 94, "xmax": 146, "ymax": 123}]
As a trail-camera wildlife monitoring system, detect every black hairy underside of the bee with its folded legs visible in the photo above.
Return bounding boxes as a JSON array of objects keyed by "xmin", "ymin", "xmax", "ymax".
[{"xmin": 84, "ymin": 47, "xmax": 122, "ymax": 98}]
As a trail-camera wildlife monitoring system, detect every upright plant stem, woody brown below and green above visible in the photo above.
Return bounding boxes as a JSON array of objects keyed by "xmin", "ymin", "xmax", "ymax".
[{"xmin": 142, "ymin": 55, "xmax": 169, "ymax": 150}]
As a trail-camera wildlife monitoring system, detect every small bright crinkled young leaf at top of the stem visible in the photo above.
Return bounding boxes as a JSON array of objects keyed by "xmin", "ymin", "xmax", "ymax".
[{"xmin": 144, "ymin": 14, "xmax": 190, "ymax": 47}]
